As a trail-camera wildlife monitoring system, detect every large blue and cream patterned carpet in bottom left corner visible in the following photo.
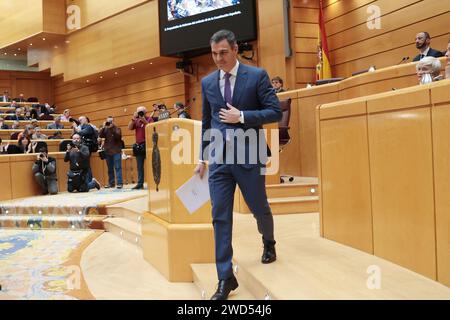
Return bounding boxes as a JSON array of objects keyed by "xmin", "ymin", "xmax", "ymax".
[{"xmin": 0, "ymin": 229, "xmax": 102, "ymax": 300}]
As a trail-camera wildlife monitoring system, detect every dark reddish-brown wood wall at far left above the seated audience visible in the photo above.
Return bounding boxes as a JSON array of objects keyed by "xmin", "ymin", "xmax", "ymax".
[{"xmin": 0, "ymin": 70, "xmax": 53, "ymax": 104}]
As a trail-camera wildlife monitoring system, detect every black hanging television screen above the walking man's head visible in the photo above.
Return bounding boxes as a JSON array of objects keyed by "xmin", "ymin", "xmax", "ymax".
[{"xmin": 159, "ymin": 0, "xmax": 256, "ymax": 57}]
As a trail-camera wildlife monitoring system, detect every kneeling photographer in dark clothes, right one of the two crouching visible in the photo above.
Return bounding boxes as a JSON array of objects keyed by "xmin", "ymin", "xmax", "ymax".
[{"xmin": 64, "ymin": 133, "xmax": 100, "ymax": 192}]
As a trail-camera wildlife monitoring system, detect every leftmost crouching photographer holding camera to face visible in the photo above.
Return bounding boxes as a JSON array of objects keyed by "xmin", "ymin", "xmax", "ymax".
[{"xmin": 32, "ymin": 148, "xmax": 58, "ymax": 195}]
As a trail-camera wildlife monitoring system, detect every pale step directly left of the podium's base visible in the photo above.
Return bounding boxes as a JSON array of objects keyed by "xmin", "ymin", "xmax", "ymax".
[{"xmin": 103, "ymin": 217, "xmax": 142, "ymax": 248}]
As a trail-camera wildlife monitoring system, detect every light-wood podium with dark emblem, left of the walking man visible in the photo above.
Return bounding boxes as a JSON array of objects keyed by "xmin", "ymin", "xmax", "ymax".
[{"xmin": 142, "ymin": 118, "xmax": 215, "ymax": 282}]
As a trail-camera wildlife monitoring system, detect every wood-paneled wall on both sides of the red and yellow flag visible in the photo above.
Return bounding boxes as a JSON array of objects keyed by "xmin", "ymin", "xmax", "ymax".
[{"xmin": 292, "ymin": 0, "xmax": 450, "ymax": 84}]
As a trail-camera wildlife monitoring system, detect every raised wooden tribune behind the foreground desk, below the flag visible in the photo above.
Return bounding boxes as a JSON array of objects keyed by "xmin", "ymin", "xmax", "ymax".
[{"xmin": 278, "ymin": 58, "xmax": 445, "ymax": 177}]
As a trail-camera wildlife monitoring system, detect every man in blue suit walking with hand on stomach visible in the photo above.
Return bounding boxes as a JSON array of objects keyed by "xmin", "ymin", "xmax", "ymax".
[{"xmin": 195, "ymin": 30, "xmax": 282, "ymax": 300}]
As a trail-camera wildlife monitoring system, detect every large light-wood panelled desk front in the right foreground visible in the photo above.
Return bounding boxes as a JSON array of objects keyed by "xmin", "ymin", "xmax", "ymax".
[{"xmin": 317, "ymin": 79, "xmax": 450, "ymax": 286}]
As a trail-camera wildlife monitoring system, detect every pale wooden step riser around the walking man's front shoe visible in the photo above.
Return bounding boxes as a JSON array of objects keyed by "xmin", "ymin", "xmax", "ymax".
[{"xmin": 191, "ymin": 263, "xmax": 255, "ymax": 300}]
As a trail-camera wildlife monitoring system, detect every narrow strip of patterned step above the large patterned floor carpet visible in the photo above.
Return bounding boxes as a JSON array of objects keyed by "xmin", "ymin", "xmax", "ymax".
[{"xmin": 0, "ymin": 214, "xmax": 105, "ymax": 230}]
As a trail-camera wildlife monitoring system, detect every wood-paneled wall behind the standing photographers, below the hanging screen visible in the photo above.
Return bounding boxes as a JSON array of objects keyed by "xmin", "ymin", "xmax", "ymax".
[{"xmin": 54, "ymin": 63, "xmax": 185, "ymax": 145}]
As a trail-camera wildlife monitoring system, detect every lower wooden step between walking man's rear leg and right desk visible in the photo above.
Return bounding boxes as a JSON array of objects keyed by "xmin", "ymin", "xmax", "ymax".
[{"xmin": 268, "ymin": 196, "xmax": 319, "ymax": 214}]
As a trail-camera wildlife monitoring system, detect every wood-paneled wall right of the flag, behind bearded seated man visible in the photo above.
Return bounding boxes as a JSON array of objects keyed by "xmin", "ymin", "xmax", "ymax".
[{"xmin": 324, "ymin": 0, "xmax": 450, "ymax": 77}]
